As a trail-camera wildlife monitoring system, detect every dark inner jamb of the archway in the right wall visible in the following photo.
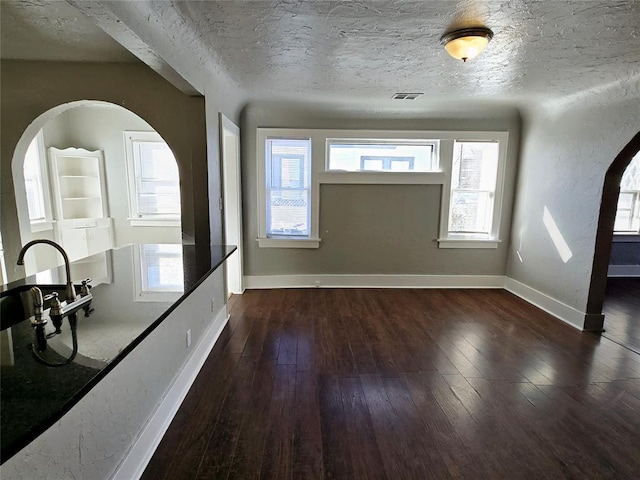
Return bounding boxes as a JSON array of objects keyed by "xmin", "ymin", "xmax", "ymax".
[{"xmin": 585, "ymin": 132, "xmax": 640, "ymax": 330}]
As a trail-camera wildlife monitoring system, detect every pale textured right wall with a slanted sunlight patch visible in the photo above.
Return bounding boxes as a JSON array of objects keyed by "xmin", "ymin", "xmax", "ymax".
[{"xmin": 507, "ymin": 92, "xmax": 640, "ymax": 312}]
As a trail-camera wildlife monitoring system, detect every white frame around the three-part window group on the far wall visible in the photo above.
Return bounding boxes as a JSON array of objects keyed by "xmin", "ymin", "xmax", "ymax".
[{"xmin": 256, "ymin": 128, "xmax": 509, "ymax": 248}]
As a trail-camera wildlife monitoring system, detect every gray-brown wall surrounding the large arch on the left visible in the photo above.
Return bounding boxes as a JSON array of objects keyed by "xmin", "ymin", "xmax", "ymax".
[{"xmin": 0, "ymin": 60, "xmax": 208, "ymax": 280}]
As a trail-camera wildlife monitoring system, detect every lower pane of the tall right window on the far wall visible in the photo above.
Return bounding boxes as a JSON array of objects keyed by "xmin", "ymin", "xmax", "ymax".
[{"xmin": 449, "ymin": 191, "xmax": 493, "ymax": 234}]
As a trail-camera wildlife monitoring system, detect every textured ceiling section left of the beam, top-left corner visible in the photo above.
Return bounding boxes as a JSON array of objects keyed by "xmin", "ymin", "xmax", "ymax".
[{"xmin": 0, "ymin": 0, "xmax": 137, "ymax": 62}]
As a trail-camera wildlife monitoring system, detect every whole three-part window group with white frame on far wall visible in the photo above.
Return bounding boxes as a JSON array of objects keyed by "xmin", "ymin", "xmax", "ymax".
[{"xmin": 257, "ymin": 128, "xmax": 508, "ymax": 248}]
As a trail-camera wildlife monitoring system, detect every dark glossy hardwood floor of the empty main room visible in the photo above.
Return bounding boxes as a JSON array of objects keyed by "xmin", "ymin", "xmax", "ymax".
[{"xmin": 143, "ymin": 289, "xmax": 640, "ymax": 480}]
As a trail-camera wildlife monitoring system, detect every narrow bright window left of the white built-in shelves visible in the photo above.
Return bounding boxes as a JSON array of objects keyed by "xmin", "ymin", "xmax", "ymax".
[{"xmin": 24, "ymin": 131, "xmax": 52, "ymax": 231}]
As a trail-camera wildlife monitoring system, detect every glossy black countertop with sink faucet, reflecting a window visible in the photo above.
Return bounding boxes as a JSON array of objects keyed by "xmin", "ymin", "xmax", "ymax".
[{"xmin": 0, "ymin": 244, "xmax": 236, "ymax": 463}]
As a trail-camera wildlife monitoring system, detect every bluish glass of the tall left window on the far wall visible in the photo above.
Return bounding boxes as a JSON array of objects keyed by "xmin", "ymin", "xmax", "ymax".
[{"xmin": 266, "ymin": 138, "xmax": 311, "ymax": 237}]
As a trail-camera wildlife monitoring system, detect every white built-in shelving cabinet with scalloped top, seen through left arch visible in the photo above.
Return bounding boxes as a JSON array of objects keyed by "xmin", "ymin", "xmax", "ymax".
[{"xmin": 49, "ymin": 147, "xmax": 113, "ymax": 260}]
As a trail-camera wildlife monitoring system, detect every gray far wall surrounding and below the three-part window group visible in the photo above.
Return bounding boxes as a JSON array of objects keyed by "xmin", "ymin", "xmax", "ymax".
[{"xmin": 240, "ymin": 104, "xmax": 520, "ymax": 275}]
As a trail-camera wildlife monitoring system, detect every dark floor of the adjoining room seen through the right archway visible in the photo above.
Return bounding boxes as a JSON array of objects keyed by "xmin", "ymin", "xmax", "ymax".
[{"xmin": 602, "ymin": 278, "xmax": 640, "ymax": 353}]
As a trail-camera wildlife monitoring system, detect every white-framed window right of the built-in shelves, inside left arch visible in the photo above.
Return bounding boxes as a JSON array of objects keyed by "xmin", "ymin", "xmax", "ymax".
[{"xmin": 125, "ymin": 132, "xmax": 180, "ymax": 225}]
